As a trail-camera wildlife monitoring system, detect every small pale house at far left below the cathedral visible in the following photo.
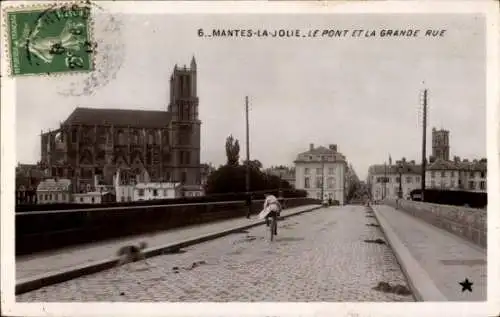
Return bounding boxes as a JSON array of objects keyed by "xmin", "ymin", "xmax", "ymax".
[{"xmin": 36, "ymin": 178, "xmax": 71, "ymax": 204}]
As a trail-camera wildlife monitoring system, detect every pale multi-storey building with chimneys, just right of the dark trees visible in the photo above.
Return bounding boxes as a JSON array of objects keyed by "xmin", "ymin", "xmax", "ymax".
[{"xmin": 294, "ymin": 144, "xmax": 347, "ymax": 205}]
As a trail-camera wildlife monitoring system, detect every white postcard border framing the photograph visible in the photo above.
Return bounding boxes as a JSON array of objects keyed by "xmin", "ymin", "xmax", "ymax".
[{"xmin": 0, "ymin": 1, "xmax": 500, "ymax": 316}]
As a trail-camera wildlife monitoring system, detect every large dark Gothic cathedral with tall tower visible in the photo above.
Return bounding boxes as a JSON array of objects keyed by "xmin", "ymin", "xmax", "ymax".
[{"xmin": 41, "ymin": 57, "xmax": 201, "ymax": 192}]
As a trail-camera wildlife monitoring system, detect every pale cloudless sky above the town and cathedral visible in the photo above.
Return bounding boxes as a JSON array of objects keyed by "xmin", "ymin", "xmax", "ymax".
[{"xmin": 16, "ymin": 14, "xmax": 486, "ymax": 179}]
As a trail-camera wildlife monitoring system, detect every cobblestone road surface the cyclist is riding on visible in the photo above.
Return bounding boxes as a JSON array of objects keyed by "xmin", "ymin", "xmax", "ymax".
[{"xmin": 17, "ymin": 206, "xmax": 413, "ymax": 302}]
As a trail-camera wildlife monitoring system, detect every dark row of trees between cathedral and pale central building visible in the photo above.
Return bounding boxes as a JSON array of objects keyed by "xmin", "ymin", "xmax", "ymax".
[{"xmin": 206, "ymin": 135, "xmax": 306, "ymax": 197}]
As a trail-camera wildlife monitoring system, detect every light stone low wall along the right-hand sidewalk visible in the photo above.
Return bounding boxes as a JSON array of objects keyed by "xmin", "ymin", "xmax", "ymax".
[{"xmin": 384, "ymin": 199, "xmax": 487, "ymax": 248}]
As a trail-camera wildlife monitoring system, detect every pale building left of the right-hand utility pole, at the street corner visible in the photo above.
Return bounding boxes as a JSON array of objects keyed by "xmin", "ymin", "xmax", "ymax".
[{"xmin": 367, "ymin": 159, "xmax": 421, "ymax": 200}]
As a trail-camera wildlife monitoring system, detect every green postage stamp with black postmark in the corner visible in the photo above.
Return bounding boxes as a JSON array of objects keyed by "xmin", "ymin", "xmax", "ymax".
[{"xmin": 5, "ymin": 3, "xmax": 95, "ymax": 76}]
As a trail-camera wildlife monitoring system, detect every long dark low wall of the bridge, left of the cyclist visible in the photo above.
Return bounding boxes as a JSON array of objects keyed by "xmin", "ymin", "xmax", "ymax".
[{"xmin": 15, "ymin": 198, "xmax": 320, "ymax": 255}]
